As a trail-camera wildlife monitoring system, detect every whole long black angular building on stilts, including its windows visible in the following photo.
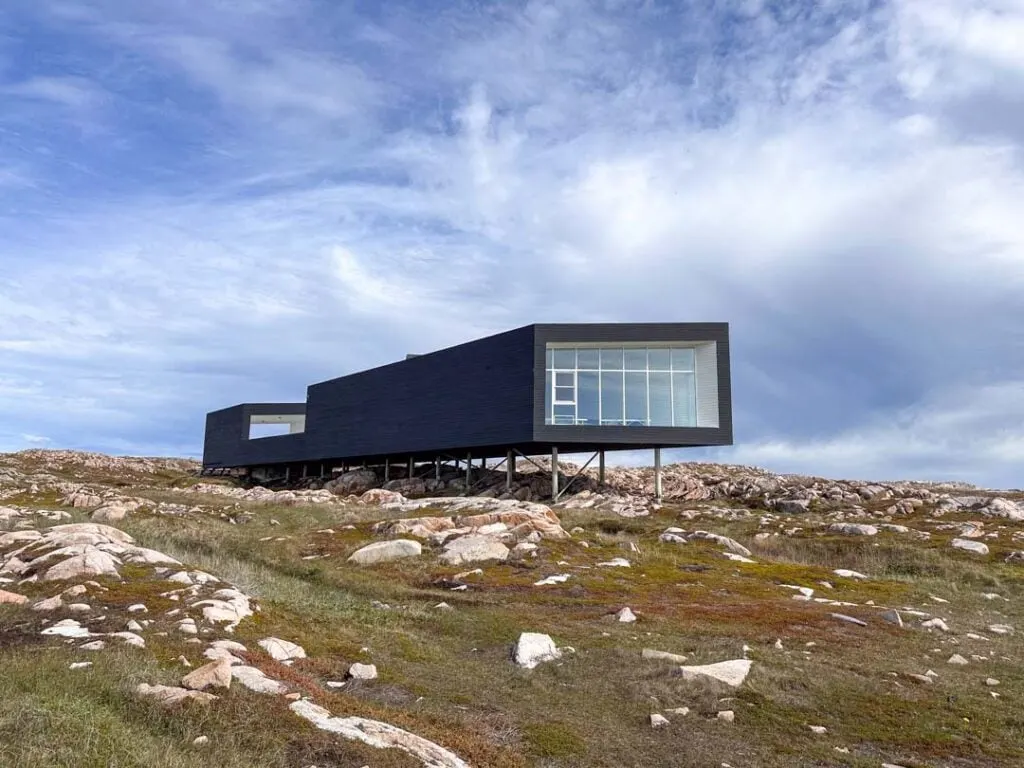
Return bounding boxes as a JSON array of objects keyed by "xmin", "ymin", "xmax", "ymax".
[{"xmin": 203, "ymin": 323, "xmax": 732, "ymax": 498}]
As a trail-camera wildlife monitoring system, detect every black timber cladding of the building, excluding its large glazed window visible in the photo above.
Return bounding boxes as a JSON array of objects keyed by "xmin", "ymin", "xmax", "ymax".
[{"xmin": 203, "ymin": 323, "xmax": 732, "ymax": 469}]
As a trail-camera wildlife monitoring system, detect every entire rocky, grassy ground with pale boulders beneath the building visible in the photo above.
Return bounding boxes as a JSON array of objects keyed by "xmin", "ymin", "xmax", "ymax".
[{"xmin": 0, "ymin": 451, "xmax": 1024, "ymax": 768}]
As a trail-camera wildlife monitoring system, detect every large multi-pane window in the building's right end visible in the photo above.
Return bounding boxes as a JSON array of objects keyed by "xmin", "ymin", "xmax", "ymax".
[{"xmin": 545, "ymin": 345, "xmax": 696, "ymax": 427}]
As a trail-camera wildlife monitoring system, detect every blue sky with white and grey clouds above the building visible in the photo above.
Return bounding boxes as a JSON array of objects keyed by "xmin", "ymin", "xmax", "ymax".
[{"xmin": 0, "ymin": 0, "xmax": 1024, "ymax": 487}]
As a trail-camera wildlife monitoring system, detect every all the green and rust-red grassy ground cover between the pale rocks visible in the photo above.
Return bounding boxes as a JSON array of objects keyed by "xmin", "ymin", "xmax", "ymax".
[{"xmin": 0, "ymin": 456, "xmax": 1024, "ymax": 768}]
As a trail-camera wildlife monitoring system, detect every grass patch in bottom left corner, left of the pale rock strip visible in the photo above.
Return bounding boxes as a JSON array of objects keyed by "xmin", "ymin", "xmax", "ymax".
[{"xmin": 0, "ymin": 648, "xmax": 417, "ymax": 768}]
